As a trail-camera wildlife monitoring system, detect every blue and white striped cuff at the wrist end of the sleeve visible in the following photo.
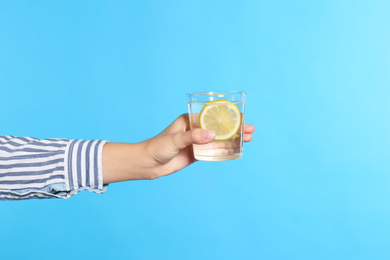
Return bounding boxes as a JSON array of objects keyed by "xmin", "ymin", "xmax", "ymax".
[{"xmin": 65, "ymin": 140, "xmax": 108, "ymax": 197}]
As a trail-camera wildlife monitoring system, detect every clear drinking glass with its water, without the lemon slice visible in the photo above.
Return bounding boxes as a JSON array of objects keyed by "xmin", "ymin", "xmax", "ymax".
[{"xmin": 187, "ymin": 91, "xmax": 246, "ymax": 161}]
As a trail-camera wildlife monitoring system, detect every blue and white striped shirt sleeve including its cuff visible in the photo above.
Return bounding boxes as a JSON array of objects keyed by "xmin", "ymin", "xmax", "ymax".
[{"xmin": 0, "ymin": 135, "xmax": 107, "ymax": 200}]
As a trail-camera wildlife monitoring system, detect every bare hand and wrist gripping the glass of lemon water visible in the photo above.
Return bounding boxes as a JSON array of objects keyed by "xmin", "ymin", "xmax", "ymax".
[{"xmin": 102, "ymin": 114, "xmax": 255, "ymax": 184}]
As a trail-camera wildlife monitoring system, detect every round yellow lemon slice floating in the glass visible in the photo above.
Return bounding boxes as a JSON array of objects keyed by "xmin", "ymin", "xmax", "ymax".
[{"xmin": 199, "ymin": 99, "xmax": 241, "ymax": 140}]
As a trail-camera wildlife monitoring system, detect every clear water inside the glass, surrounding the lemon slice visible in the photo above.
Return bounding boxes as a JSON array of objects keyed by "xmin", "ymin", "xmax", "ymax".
[{"xmin": 188, "ymin": 102, "xmax": 244, "ymax": 161}]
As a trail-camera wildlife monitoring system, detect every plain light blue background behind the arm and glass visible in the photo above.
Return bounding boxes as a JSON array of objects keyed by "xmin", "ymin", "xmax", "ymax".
[{"xmin": 0, "ymin": 0, "xmax": 390, "ymax": 260}]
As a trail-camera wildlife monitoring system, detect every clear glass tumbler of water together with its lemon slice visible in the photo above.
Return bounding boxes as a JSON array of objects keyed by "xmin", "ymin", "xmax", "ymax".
[{"xmin": 187, "ymin": 91, "xmax": 246, "ymax": 161}]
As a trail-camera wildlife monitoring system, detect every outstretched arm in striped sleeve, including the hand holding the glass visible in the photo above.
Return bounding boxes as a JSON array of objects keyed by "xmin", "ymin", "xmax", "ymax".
[{"xmin": 0, "ymin": 114, "xmax": 254, "ymax": 200}]
